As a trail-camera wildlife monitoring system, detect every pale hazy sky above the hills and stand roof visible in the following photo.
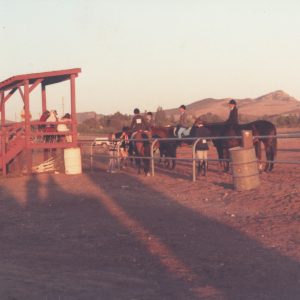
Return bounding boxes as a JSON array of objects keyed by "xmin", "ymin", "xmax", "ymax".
[{"xmin": 0, "ymin": 0, "xmax": 300, "ymax": 118}]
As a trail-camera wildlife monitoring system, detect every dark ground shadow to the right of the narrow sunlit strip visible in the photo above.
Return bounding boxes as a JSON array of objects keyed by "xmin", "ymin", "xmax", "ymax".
[{"xmin": 90, "ymin": 173, "xmax": 300, "ymax": 299}]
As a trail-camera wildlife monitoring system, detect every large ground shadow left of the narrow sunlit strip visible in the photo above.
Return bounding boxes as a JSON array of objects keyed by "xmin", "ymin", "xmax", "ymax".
[{"xmin": 0, "ymin": 175, "xmax": 197, "ymax": 300}]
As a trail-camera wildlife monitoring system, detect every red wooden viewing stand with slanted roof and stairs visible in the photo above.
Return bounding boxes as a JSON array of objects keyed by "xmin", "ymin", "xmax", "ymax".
[{"xmin": 0, "ymin": 68, "xmax": 81, "ymax": 175}]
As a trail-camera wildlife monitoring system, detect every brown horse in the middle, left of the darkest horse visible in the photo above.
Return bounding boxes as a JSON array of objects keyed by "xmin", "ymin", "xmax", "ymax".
[{"xmin": 151, "ymin": 126, "xmax": 178, "ymax": 169}]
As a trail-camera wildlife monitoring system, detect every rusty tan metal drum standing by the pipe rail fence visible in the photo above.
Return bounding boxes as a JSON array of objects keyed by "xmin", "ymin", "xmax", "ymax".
[{"xmin": 229, "ymin": 147, "xmax": 260, "ymax": 191}]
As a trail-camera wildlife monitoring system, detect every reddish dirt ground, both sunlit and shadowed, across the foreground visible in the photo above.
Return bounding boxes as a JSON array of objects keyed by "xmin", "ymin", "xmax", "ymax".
[{"xmin": 0, "ymin": 135, "xmax": 300, "ymax": 300}]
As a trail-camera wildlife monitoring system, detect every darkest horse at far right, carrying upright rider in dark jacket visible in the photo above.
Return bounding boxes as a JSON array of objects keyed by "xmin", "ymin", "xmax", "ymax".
[{"xmin": 191, "ymin": 120, "xmax": 277, "ymax": 172}]
